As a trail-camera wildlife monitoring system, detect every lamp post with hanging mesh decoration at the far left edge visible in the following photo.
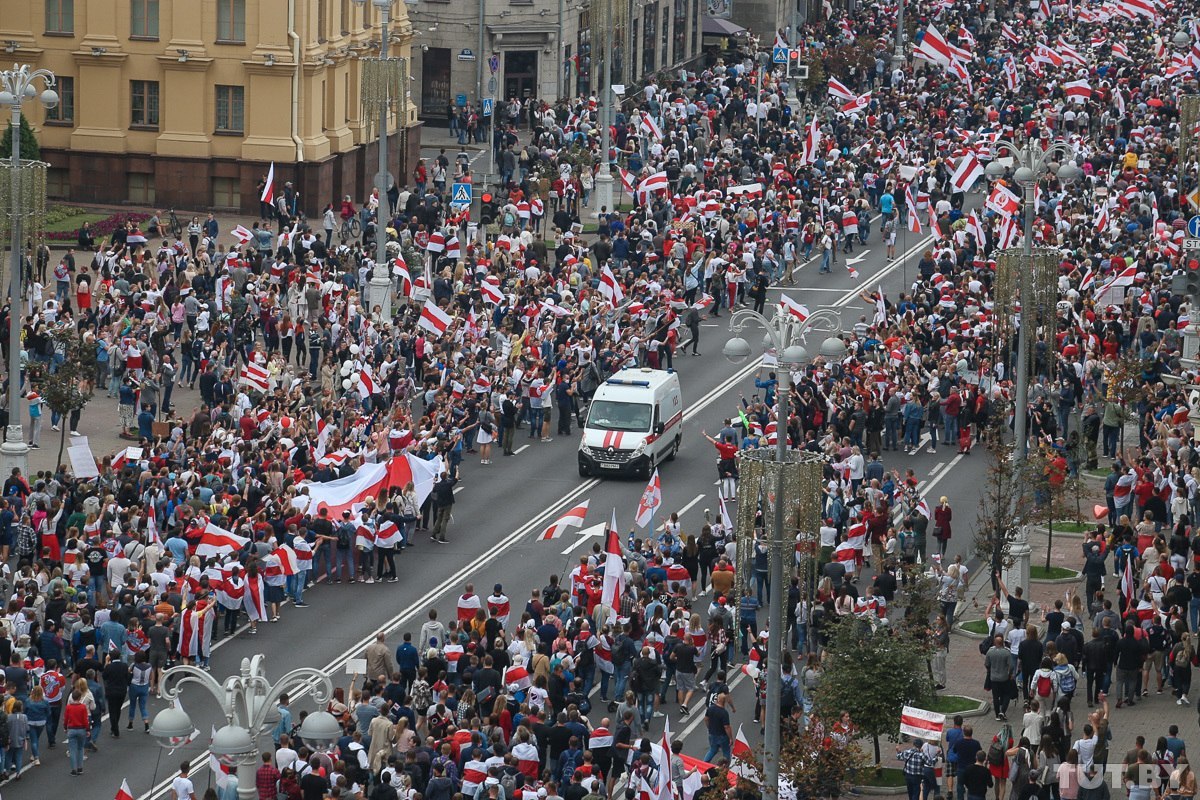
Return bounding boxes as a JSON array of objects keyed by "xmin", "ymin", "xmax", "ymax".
[{"xmin": 0, "ymin": 64, "xmax": 59, "ymax": 475}]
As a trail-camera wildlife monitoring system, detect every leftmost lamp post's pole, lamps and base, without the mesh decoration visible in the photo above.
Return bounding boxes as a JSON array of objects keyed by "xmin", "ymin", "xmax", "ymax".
[{"xmin": 0, "ymin": 64, "xmax": 59, "ymax": 474}]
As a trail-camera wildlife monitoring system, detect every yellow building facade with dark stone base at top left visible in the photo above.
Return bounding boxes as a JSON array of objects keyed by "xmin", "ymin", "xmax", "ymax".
[{"xmin": 0, "ymin": 0, "xmax": 420, "ymax": 215}]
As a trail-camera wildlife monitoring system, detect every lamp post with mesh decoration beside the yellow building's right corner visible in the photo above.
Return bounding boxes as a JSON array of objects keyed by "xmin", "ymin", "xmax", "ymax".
[{"xmin": 354, "ymin": 0, "xmax": 408, "ymax": 319}]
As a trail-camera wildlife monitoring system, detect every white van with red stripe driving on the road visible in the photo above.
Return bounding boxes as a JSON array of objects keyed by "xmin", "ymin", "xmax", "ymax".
[{"xmin": 580, "ymin": 367, "xmax": 683, "ymax": 477}]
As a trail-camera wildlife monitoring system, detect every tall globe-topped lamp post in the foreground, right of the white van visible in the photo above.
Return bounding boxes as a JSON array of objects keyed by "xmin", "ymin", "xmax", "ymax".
[{"xmin": 722, "ymin": 306, "xmax": 846, "ymax": 800}]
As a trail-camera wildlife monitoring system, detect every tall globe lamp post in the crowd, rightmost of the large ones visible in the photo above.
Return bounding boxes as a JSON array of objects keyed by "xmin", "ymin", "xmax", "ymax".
[{"xmin": 986, "ymin": 139, "xmax": 1082, "ymax": 587}]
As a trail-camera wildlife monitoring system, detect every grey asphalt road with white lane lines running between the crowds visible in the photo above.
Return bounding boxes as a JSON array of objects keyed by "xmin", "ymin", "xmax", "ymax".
[{"xmin": 16, "ymin": 196, "xmax": 985, "ymax": 800}]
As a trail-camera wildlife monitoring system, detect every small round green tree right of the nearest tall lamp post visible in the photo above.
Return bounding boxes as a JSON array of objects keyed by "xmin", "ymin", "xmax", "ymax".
[{"xmin": 815, "ymin": 618, "xmax": 934, "ymax": 766}]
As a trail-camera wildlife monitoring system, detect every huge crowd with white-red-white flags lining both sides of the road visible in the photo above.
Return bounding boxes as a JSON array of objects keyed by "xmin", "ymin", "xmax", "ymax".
[{"xmin": 0, "ymin": 0, "xmax": 1200, "ymax": 800}]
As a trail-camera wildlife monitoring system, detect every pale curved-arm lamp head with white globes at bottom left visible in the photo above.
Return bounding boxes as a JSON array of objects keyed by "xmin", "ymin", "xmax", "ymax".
[{"xmin": 150, "ymin": 654, "xmax": 342, "ymax": 800}]
